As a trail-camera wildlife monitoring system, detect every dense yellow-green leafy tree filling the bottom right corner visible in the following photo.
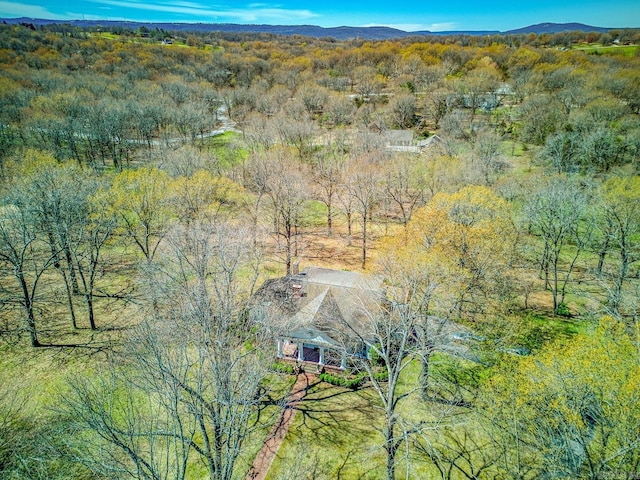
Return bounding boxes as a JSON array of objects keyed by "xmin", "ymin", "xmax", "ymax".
[{"xmin": 484, "ymin": 318, "xmax": 640, "ymax": 478}]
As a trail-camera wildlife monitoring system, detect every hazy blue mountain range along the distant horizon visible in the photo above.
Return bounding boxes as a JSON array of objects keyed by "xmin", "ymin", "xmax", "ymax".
[{"xmin": 0, "ymin": 17, "xmax": 624, "ymax": 40}]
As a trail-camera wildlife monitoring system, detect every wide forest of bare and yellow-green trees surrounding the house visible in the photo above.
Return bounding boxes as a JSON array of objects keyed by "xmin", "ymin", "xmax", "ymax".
[{"xmin": 0, "ymin": 24, "xmax": 640, "ymax": 480}]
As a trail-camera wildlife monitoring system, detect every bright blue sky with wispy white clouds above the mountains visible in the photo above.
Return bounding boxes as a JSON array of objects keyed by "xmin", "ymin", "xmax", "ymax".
[{"xmin": 0, "ymin": 0, "xmax": 640, "ymax": 32}]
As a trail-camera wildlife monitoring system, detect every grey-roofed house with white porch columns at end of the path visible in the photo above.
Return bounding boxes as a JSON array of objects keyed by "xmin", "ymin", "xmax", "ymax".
[{"xmin": 252, "ymin": 267, "xmax": 384, "ymax": 371}]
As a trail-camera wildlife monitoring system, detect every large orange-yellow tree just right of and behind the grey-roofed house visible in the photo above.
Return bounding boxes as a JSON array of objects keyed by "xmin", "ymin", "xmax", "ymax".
[{"xmin": 385, "ymin": 186, "xmax": 515, "ymax": 318}]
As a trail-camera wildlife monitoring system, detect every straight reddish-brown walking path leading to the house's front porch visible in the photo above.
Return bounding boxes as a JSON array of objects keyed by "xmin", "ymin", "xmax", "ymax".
[{"xmin": 246, "ymin": 372, "xmax": 315, "ymax": 480}]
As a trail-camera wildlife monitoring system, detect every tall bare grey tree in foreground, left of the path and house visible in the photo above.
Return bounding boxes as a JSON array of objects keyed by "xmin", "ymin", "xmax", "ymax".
[{"xmin": 66, "ymin": 221, "xmax": 272, "ymax": 480}]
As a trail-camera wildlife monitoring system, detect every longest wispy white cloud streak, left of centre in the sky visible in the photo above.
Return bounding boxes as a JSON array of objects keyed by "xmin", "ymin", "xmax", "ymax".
[{"xmin": 93, "ymin": 0, "xmax": 318, "ymax": 23}]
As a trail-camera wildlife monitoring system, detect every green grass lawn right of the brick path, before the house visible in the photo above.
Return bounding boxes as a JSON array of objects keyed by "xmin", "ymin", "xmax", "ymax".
[{"xmin": 267, "ymin": 362, "xmax": 476, "ymax": 480}]
